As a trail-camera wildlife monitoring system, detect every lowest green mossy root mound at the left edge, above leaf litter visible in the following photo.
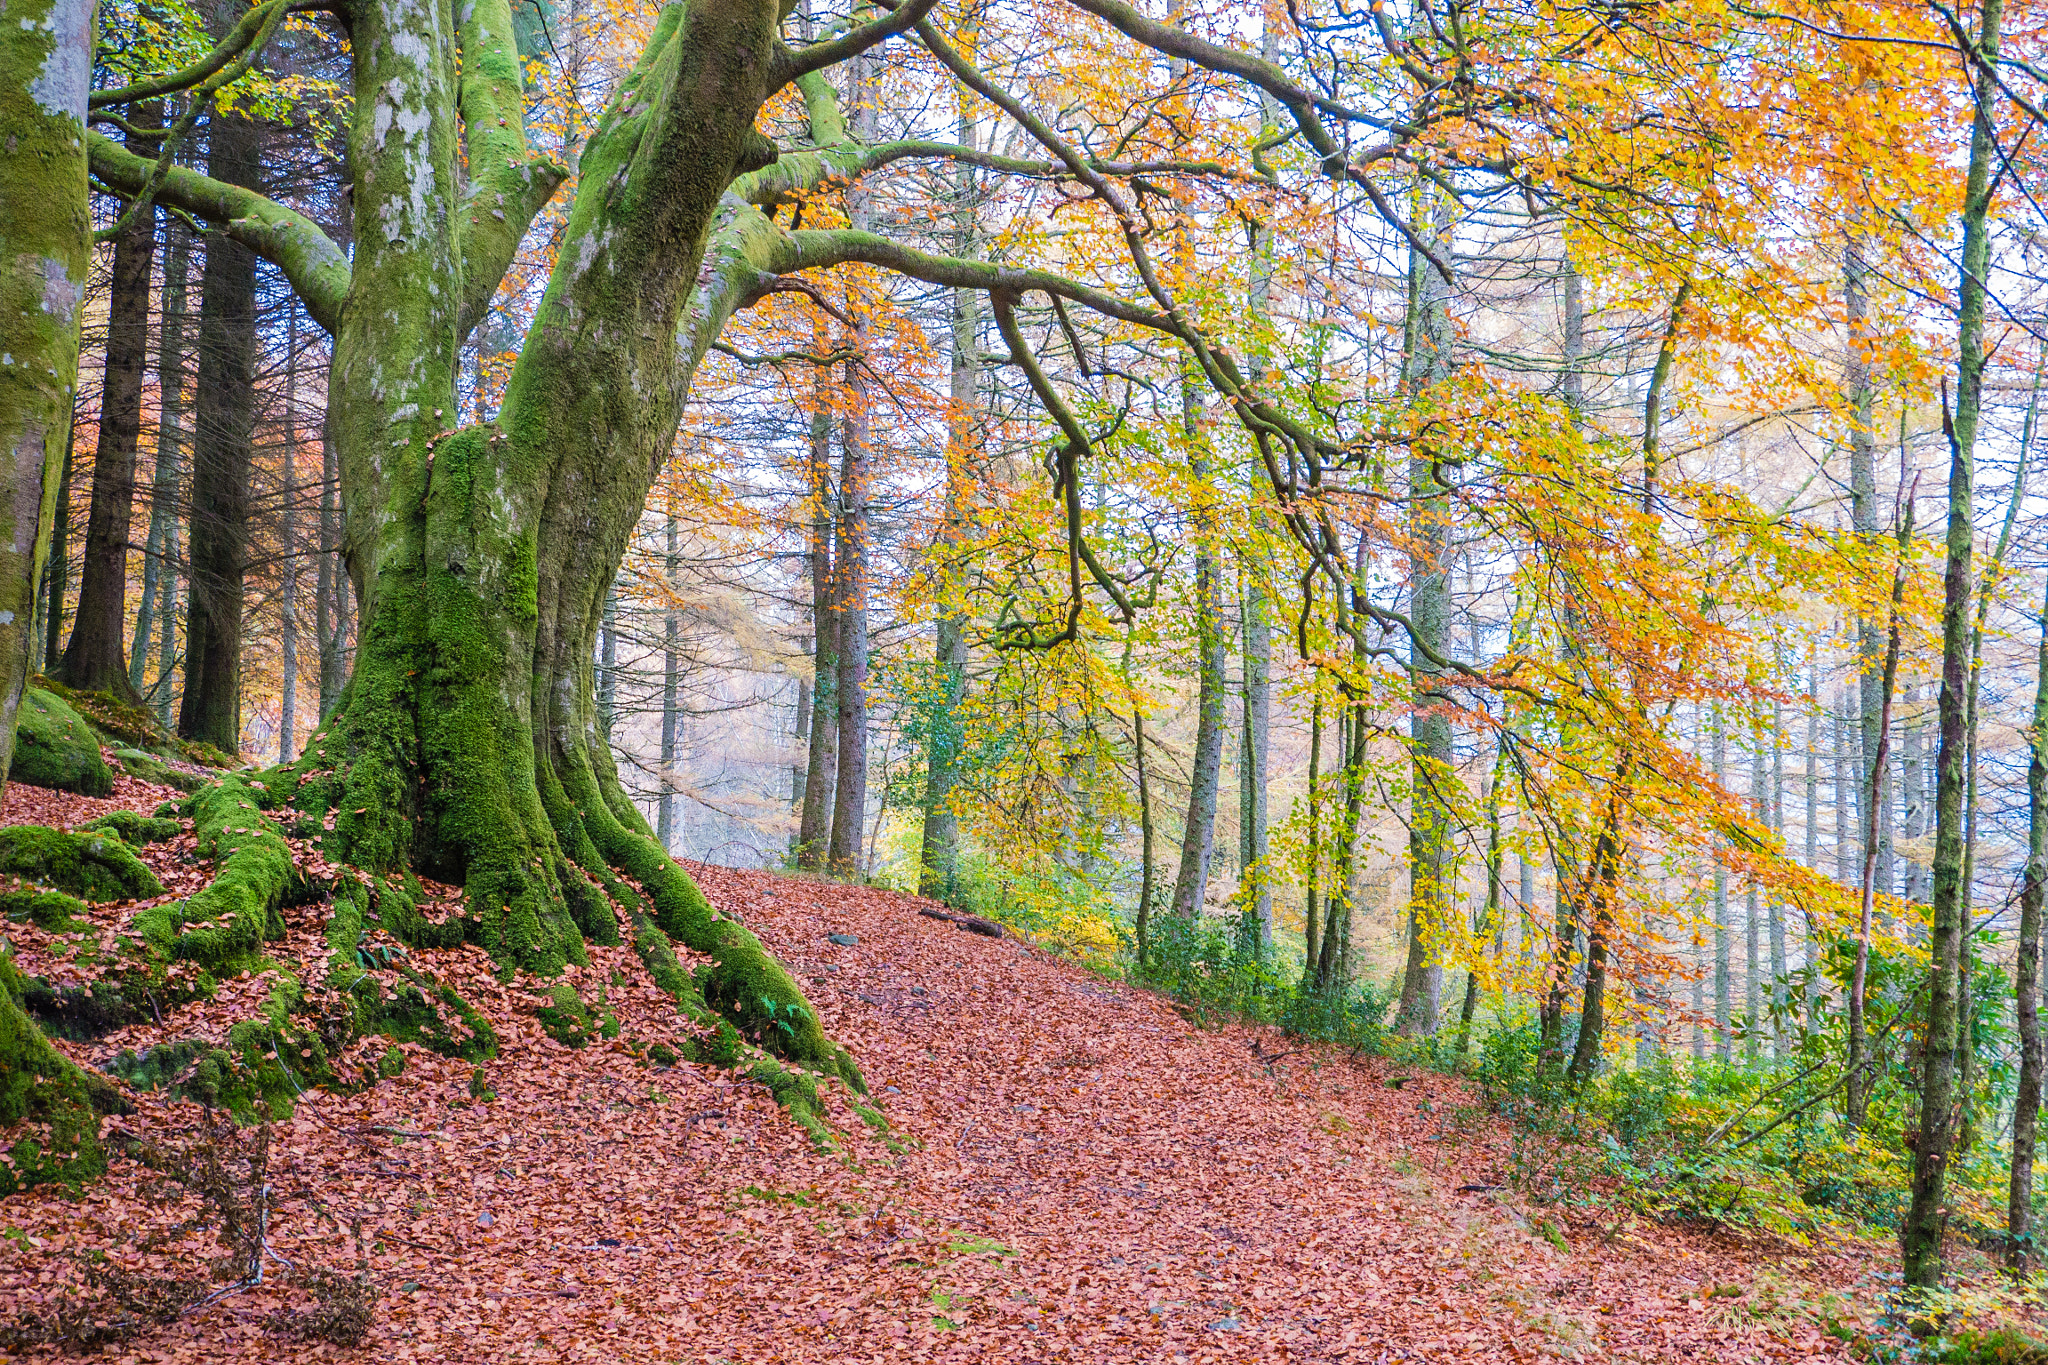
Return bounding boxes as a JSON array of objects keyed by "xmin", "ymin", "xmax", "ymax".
[{"xmin": 0, "ymin": 948, "xmax": 106, "ymax": 1195}]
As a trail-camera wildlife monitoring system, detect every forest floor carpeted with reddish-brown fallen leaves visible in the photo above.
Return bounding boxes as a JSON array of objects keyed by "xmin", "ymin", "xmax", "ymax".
[{"xmin": 0, "ymin": 780, "xmax": 1886, "ymax": 1365}]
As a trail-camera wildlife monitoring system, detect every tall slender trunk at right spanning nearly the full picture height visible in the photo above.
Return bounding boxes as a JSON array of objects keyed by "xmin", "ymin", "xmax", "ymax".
[{"xmin": 1898, "ymin": 0, "xmax": 2003, "ymax": 1289}]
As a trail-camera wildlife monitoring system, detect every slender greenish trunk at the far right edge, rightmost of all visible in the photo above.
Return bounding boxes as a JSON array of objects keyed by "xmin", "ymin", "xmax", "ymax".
[{"xmin": 2005, "ymin": 573, "xmax": 2048, "ymax": 1275}]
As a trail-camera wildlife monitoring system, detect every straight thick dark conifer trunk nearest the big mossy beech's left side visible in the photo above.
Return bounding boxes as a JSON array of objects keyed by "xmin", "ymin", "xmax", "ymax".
[{"xmin": 178, "ymin": 98, "xmax": 262, "ymax": 753}]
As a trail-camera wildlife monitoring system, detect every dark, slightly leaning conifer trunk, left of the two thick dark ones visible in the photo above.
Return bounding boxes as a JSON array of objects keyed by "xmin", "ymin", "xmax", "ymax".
[{"xmin": 55, "ymin": 100, "xmax": 164, "ymax": 704}]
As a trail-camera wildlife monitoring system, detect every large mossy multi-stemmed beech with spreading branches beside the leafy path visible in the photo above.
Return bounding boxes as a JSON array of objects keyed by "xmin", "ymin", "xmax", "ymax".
[{"xmin": 59, "ymin": 0, "xmax": 1761, "ymax": 1129}]
